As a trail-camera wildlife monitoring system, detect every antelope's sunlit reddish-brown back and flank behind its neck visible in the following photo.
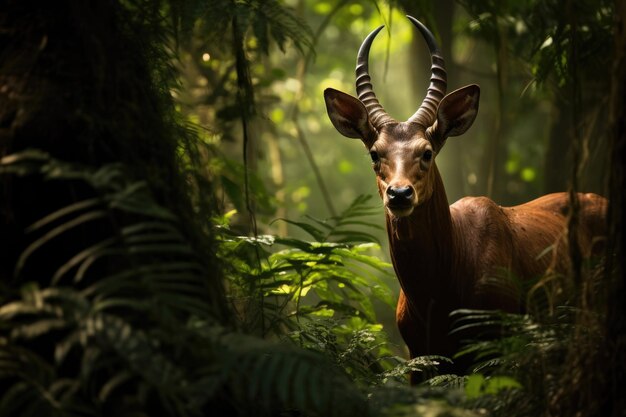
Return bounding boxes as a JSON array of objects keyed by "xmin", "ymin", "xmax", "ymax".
[{"xmin": 450, "ymin": 193, "xmax": 608, "ymax": 311}]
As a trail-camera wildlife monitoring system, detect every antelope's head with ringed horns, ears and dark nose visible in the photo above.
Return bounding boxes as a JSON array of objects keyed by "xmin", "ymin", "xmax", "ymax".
[{"xmin": 324, "ymin": 16, "xmax": 480, "ymax": 217}]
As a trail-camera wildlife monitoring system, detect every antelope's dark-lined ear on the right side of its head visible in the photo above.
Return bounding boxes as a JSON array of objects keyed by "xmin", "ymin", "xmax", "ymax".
[{"xmin": 433, "ymin": 84, "xmax": 480, "ymax": 140}]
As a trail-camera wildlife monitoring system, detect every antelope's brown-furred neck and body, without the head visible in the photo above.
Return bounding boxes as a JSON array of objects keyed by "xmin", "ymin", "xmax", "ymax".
[{"xmin": 387, "ymin": 169, "xmax": 607, "ymax": 380}]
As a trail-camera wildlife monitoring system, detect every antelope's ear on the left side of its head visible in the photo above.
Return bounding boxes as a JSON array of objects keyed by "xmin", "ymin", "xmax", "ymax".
[{"xmin": 324, "ymin": 88, "xmax": 376, "ymax": 145}]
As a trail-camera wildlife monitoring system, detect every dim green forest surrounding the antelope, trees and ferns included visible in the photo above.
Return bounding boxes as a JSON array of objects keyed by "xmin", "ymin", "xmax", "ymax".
[{"xmin": 0, "ymin": 0, "xmax": 626, "ymax": 417}]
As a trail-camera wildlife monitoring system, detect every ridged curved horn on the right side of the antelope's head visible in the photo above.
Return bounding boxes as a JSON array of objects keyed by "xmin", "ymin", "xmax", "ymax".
[{"xmin": 407, "ymin": 16, "xmax": 448, "ymax": 126}]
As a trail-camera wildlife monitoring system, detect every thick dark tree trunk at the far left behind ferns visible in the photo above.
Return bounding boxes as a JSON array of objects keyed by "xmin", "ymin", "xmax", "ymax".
[{"xmin": 0, "ymin": 0, "xmax": 228, "ymax": 318}]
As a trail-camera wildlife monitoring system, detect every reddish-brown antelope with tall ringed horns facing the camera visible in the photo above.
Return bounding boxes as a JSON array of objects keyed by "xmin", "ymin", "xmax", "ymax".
[{"xmin": 324, "ymin": 16, "xmax": 607, "ymax": 383}]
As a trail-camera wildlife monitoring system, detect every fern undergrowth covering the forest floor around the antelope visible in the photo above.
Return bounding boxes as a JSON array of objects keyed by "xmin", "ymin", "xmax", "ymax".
[{"xmin": 0, "ymin": 151, "xmax": 612, "ymax": 416}]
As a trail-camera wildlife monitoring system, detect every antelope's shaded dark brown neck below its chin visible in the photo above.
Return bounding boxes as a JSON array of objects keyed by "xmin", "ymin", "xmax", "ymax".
[{"xmin": 387, "ymin": 167, "xmax": 456, "ymax": 303}]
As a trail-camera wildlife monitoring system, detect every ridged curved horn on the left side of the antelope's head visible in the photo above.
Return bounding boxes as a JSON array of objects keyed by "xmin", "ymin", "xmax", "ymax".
[{"xmin": 356, "ymin": 26, "xmax": 395, "ymax": 130}]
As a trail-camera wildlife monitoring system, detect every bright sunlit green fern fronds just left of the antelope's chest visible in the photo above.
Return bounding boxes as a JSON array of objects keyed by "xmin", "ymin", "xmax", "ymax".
[{"xmin": 220, "ymin": 197, "xmax": 393, "ymax": 328}]
